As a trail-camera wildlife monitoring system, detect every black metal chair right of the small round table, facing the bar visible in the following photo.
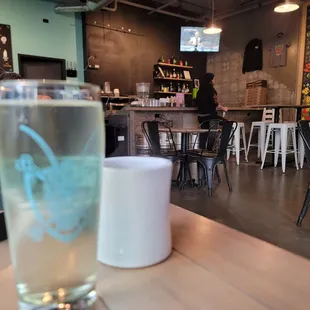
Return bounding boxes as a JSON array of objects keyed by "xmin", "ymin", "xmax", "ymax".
[{"xmin": 189, "ymin": 120, "xmax": 237, "ymax": 196}]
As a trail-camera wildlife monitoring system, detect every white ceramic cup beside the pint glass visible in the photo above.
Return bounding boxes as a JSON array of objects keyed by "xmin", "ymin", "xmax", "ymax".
[{"xmin": 98, "ymin": 157, "xmax": 172, "ymax": 268}]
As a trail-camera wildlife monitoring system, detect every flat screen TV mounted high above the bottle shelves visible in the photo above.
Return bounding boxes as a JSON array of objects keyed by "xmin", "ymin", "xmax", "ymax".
[{"xmin": 180, "ymin": 27, "xmax": 221, "ymax": 52}]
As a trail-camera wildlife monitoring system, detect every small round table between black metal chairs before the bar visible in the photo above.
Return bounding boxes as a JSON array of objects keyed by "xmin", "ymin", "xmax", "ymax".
[{"xmin": 159, "ymin": 127, "xmax": 209, "ymax": 188}]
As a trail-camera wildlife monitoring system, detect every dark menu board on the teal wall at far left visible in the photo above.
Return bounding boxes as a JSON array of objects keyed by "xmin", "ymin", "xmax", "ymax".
[{"xmin": 0, "ymin": 24, "xmax": 13, "ymax": 72}]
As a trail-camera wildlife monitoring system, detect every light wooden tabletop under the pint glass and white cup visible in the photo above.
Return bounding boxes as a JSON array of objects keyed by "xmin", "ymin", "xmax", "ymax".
[{"xmin": 0, "ymin": 206, "xmax": 310, "ymax": 310}]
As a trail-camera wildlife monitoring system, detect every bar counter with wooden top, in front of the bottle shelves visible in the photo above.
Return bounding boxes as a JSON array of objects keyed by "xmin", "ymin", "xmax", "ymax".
[{"xmin": 125, "ymin": 107, "xmax": 263, "ymax": 155}]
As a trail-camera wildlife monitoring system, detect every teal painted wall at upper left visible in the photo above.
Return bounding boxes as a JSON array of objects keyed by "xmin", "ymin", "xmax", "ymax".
[{"xmin": 0, "ymin": 0, "xmax": 84, "ymax": 81}]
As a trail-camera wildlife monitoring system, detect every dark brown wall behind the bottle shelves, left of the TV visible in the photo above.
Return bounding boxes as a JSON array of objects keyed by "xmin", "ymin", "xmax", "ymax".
[{"xmin": 85, "ymin": 5, "xmax": 206, "ymax": 94}]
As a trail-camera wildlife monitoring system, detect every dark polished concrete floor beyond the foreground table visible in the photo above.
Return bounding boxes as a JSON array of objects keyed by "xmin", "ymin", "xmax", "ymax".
[{"xmin": 171, "ymin": 155, "xmax": 310, "ymax": 258}]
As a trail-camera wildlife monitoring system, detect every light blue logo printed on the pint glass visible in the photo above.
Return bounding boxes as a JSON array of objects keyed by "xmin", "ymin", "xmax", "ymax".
[{"xmin": 15, "ymin": 125, "xmax": 101, "ymax": 242}]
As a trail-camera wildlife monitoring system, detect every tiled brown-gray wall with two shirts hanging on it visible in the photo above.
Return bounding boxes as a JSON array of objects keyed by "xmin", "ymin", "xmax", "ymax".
[{"xmin": 207, "ymin": 5, "xmax": 301, "ymax": 110}]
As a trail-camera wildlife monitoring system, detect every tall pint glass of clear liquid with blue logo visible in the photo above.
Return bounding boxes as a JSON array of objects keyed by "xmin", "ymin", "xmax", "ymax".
[{"xmin": 0, "ymin": 80, "xmax": 104, "ymax": 309}]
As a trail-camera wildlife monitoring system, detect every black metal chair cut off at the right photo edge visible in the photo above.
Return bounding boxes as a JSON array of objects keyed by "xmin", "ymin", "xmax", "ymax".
[{"xmin": 296, "ymin": 121, "xmax": 310, "ymax": 226}]
